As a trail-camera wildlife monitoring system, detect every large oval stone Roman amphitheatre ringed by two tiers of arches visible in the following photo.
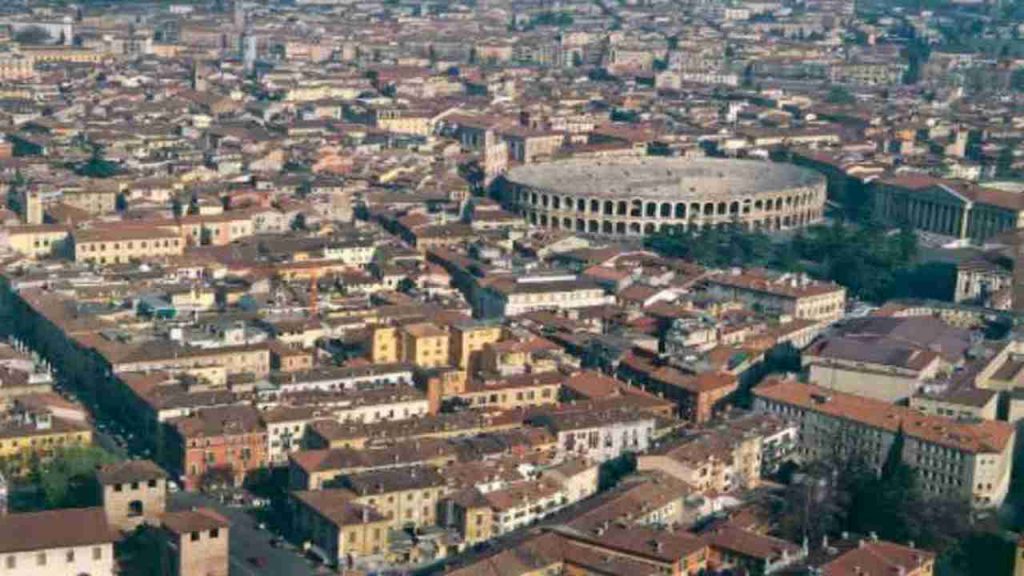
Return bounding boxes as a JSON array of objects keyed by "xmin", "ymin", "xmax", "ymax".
[{"xmin": 498, "ymin": 157, "xmax": 825, "ymax": 236}]
